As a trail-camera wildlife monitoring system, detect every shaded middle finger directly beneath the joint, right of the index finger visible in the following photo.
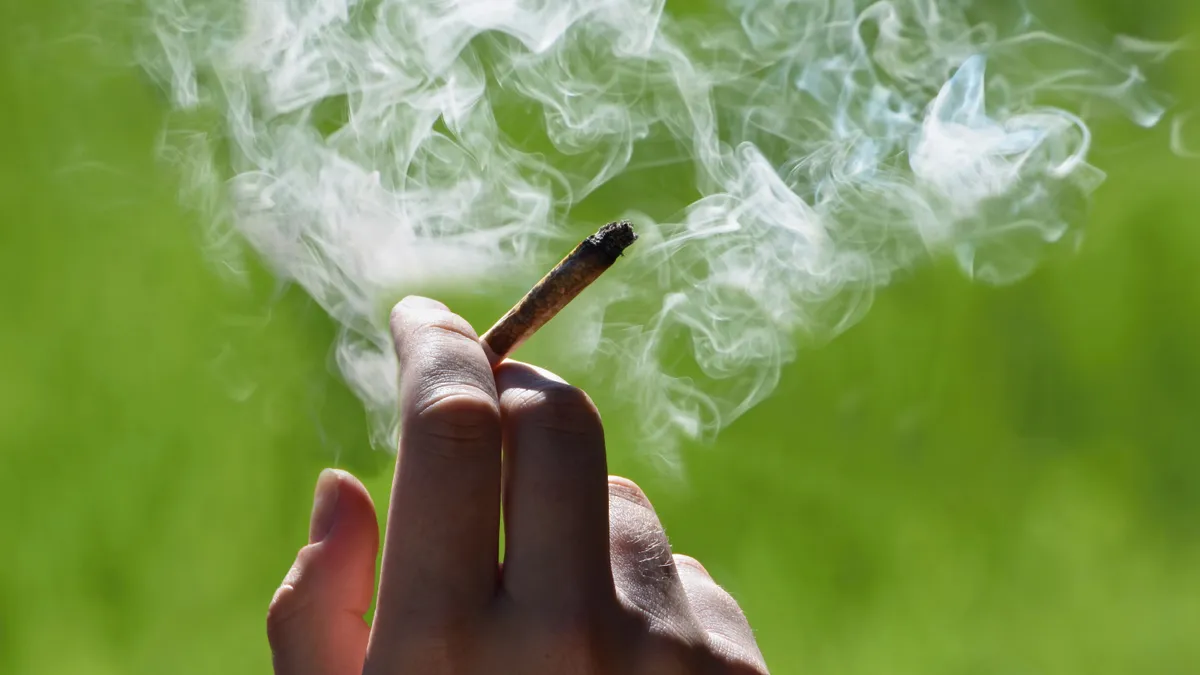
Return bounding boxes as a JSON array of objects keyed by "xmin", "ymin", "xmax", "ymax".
[{"xmin": 496, "ymin": 362, "xmax": 613, "ymax": 613}]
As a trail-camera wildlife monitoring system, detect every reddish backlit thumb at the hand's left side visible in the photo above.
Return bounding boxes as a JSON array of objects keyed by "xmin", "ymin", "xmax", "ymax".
[{"xmin": 266, "ymin": 470, "xmax": 379, "ymax": 675}]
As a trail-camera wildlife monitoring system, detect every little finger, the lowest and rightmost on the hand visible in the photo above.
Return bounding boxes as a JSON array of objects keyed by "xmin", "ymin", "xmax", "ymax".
[{"xmin": 674, "ymin": 554, "xmax": 767, "ymax": 671}]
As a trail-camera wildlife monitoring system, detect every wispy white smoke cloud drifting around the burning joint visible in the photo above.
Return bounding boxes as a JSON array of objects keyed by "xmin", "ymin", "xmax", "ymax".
[{"xmin": 143, "ymin": 0, "xmax": 1183, "ymax": 456}]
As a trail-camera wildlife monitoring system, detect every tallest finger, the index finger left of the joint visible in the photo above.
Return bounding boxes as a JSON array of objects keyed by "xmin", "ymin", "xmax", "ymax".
[{"xmin": 374, "ymin": 298, "xmax": 500, "ymax": 624}]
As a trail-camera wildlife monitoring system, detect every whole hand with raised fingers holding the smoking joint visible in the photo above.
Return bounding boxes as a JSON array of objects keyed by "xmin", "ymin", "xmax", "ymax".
[{"xmin": 266, "ymin": 298, "xmax": 767, "ymax": 675}]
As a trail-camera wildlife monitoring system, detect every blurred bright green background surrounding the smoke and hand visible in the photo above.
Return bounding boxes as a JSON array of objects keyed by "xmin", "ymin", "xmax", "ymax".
[{"xmin": 0, "ymin": 0, "xmax": 1200, "ymax": 675}]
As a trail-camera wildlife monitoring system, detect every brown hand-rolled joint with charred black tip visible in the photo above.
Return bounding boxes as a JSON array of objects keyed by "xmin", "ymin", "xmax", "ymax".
[{"xmin": 482, "ymin": 221, "xmax": 637, "ymax": 366}]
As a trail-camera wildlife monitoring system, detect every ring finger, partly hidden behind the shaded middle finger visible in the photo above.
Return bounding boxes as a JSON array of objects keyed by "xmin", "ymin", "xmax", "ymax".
[{"xmin": 608, "ymin": 477, "xmax": 698, "ymax": 637}]
